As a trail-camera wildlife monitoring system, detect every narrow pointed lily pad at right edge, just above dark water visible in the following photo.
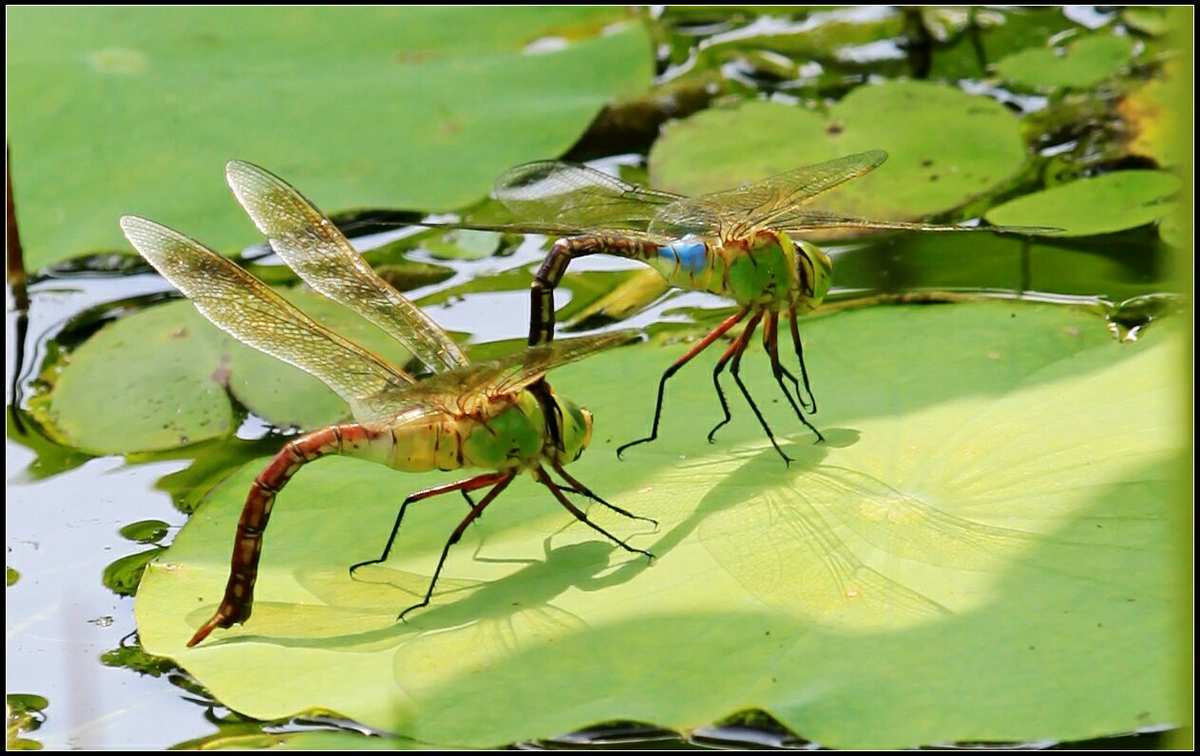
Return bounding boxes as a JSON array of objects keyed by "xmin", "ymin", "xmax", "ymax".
[{"xmin": 984, "ymin": 170, "xmax": 1180, "ymax": 236}]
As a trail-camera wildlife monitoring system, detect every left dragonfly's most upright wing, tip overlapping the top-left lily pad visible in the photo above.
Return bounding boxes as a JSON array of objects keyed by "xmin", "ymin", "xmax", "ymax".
[{"xmin": 226, "ymin": 161, "xmax": 468, "ymax": 371}]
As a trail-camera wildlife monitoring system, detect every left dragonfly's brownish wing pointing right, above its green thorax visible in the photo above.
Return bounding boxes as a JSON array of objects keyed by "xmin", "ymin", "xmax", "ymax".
[{"xmin": 404, "ymin": 331, "xmax": 641, "ymax": 410}]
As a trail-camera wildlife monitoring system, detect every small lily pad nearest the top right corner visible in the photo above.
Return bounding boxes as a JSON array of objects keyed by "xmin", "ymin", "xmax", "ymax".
[{"xmin": 996, "ymin": 35, "xmax": 1134, "ymax": 89}]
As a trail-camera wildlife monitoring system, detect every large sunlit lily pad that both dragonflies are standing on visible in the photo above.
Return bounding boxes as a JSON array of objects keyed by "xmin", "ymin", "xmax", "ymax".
[{"xmin": 136, "ymin": 302, "xmax": 1187, "ymax": 748}]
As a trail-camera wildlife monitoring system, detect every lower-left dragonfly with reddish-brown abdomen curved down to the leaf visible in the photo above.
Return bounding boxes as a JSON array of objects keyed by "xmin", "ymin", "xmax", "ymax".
[{"xmin": 120, "ymin": 161, "xmax": 654, "ymax": 647}]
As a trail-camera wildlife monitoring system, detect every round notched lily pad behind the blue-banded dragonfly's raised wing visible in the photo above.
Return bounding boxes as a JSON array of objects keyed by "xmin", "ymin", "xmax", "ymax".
[{"xmin": 650, "ymin": 82, "xmax": 1026, "ymax": 226}]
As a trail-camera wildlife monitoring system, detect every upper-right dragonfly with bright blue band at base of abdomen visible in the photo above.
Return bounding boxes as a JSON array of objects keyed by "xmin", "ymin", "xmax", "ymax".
[{"xmin": 427, "ymin": 150, "xmax": 1058, "ymax": 462}]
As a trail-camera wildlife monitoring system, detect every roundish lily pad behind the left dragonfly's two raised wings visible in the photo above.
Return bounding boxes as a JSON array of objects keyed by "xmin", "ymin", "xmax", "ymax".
[{"xmin": 40, "ymin": 290, "xmax": 412, "ymax": 454}]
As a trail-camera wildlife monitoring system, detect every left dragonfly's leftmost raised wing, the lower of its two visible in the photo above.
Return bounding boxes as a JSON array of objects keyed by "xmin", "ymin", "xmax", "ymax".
[{"xmin": 121, "ymin": 215, "xmax": 414, "ymax": 421}]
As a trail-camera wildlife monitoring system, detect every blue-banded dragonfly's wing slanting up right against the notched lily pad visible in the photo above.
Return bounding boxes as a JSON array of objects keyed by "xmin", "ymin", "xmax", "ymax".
[{"xmin": 648, "ymin": 150, "xmax": 888, "ymax": 239}]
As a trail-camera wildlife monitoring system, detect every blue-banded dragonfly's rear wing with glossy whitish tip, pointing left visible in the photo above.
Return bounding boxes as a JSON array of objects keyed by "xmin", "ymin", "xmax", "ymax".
[{"xmin": 493, "ymin": 161, "xmax": 683, "ymax": 235}]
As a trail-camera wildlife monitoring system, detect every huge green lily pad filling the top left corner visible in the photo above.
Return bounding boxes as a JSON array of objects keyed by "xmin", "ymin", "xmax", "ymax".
[{"xmin": 7, "ymin": 7, "xmax": 653, "ymax": 269}]
